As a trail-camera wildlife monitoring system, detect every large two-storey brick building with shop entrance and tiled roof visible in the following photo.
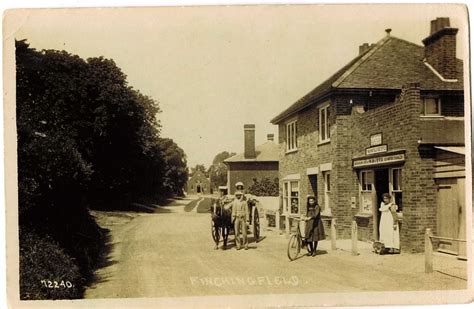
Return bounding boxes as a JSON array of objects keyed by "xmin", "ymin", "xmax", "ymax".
[{"xmin": 271, "ymin": 18, "xmax": 466, "ymax": 254}]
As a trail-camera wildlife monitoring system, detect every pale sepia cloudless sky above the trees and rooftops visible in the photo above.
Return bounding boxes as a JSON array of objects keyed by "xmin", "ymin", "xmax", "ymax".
[{"xmin": 9, "ymin": 4, "xmax": 467, "ymax": 167}]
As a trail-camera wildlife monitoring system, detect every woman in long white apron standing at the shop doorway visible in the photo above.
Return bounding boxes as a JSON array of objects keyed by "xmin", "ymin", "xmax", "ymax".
[{"xmin": 379, "ymin": 193, "xmax": 400, "ymax": 253}]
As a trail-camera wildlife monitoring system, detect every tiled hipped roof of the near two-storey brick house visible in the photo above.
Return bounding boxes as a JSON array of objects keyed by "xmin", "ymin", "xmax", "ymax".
[{"xmin": 271, "ymin": 36, "xmax": 463, "ymax": 124}]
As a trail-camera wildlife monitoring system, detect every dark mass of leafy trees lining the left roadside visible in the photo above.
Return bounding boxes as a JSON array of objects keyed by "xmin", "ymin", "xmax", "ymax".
[{"xmin": 16, "ymin": 41, "xmax": 187, "ymax": 298}]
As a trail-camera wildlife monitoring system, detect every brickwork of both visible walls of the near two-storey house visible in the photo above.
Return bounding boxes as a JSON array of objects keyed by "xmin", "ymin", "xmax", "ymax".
[{"xmin": 279, "ymin": 84, "xmax": 444, "ymax": 251}]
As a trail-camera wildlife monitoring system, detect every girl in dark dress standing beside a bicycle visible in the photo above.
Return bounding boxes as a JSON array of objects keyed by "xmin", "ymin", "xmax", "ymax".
[{"xmin": 305, "ymin": 196, "xmax": 326, "ymax": 256}]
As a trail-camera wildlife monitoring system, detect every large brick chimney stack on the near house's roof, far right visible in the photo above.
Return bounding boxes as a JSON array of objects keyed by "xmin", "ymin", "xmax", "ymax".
[{"xmin": 423, "ymin": 17, "xmax": 458, "ymax": 79}]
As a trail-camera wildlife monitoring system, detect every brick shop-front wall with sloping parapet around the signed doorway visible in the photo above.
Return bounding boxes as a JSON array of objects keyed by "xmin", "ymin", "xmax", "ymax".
[{"xmin": 351, "ymin": 84, "xmax": 436, "ymax": 251}]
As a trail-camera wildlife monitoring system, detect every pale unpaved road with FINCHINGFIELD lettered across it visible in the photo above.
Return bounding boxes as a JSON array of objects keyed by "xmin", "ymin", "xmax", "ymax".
[{"xmin": 85, "ymin": 198, "xmax": 467, "ymax": 298}]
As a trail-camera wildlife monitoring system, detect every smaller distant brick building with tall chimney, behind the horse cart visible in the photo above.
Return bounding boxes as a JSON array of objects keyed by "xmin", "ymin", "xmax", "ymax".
[{"xmin": 224, "ymin": 124, "xmax": 279, "ymax": 194}]
